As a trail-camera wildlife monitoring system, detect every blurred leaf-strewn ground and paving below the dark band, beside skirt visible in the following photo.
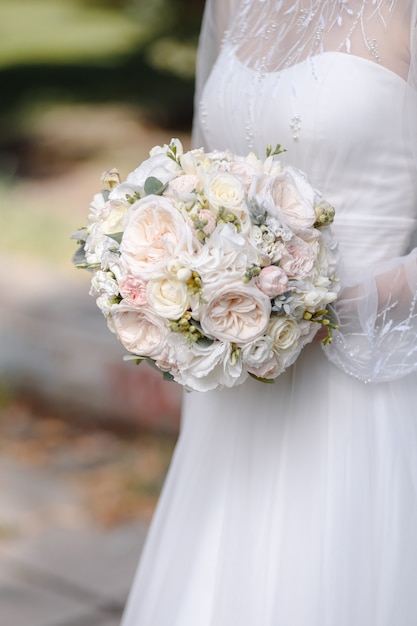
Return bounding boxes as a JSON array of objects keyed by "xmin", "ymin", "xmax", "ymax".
[{"xmin": 0, "ymin": 398, "xmax": 174, "ymax": 626}]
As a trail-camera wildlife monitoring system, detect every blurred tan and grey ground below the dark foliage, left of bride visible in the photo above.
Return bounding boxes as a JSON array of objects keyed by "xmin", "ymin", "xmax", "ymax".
[{"xmin": 0, "ymin": 105, "xmax": 189, "ymax": 626}]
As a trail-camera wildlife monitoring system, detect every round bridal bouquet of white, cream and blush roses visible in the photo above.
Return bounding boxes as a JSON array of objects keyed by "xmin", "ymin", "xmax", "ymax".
[{"xmin": 73, "ymin": 139, "xmax": 337, "ymax": 391}]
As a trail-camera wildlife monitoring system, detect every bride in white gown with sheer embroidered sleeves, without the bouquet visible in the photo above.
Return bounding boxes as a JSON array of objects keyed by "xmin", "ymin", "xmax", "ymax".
[{"xmin": 122, "ymin": 0, "xmax": 417, "ymax": 626}]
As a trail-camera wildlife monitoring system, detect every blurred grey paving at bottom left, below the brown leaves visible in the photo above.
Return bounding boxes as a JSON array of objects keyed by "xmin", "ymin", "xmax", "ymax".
[{"xmin": 0, "ymin": 457, "xmax": 147, "ymax": 626}]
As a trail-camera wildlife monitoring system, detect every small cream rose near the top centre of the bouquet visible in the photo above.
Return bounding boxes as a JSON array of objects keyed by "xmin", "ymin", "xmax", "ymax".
[{"xmin": 204, "ymin": 172, "xmax": 246, "ymax": 217}]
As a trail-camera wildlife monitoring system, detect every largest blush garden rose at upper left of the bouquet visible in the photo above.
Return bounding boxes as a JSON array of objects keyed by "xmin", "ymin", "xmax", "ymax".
[{"xmin": 120, "ymin": 196, "xmax": 192, "ymax": 280}]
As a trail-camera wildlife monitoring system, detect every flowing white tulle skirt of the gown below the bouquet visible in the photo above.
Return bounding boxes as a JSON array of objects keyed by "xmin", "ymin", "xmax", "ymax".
[{"xmin": 122, "ymin": 343, "xmax": 417, "ymax": 626}]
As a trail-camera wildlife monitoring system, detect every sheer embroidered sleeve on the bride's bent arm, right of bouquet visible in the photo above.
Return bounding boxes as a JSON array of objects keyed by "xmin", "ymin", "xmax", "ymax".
[{"xmin": 325, "ymin": 3, "xmax": 417, "ymax": 382}]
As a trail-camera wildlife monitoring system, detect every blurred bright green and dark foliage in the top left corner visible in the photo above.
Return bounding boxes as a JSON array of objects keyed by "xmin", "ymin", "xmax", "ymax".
[{"xmin": 0, "ymin": 0, "xmax": 204, "ymax": 172}]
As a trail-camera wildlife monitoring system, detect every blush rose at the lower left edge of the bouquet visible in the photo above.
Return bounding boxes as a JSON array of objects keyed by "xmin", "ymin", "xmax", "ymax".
[{"xmin": 111, "ymin": 305, "xmax": 169, "ymax": 360}]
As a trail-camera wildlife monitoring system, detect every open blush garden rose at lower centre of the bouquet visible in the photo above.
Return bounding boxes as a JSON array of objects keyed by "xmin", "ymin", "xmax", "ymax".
[{"xmin": 200, "ymin": 281, "xmax": 271, "ymax": 346}]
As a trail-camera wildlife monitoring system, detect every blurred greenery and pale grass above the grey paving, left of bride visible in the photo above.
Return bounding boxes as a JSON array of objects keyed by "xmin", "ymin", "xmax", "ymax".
[{"xmin": 0, "ymin": 0, "xmax": 204, "ymax": 269}]
